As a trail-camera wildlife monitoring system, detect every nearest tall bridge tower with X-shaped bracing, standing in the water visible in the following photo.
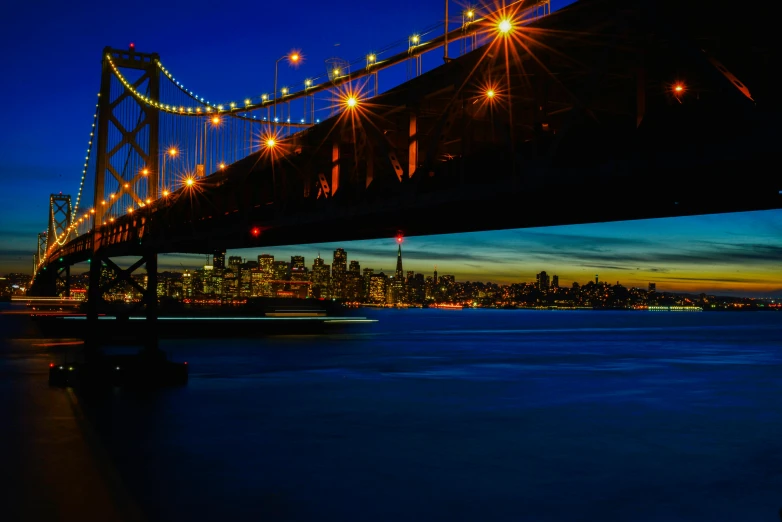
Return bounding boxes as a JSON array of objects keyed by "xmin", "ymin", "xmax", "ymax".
[{"xmin": 85, "ymin": 44, "xmax": 160, "ymax": 353}]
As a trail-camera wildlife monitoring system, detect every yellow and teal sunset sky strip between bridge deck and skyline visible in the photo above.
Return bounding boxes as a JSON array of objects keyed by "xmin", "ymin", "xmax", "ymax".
[{"xmin": 7, "ymin": 208, "xmax": 782, "ymax": 297}]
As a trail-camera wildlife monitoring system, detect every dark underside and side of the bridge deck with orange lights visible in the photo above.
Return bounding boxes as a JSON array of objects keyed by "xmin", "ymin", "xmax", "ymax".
[{"xmin": 33, "ymin": 0, "xmax": 782, "ymax": 294}]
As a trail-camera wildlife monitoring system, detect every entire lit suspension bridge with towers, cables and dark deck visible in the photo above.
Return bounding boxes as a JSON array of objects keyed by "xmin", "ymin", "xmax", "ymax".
[{"xmin": 30, "ymin": 0, "xmax": 782, "ymax": 319}]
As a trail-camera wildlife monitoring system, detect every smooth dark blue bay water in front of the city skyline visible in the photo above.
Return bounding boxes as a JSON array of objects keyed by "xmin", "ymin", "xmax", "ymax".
[{"xmin": 4, "ymin": 309, "xmax": 782, "ymax": 522}]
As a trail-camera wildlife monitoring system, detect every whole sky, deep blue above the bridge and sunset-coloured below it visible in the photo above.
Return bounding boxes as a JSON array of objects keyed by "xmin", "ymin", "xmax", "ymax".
[{"xmin": 0, "ymin": 0, "xmax": 782, "ymax": 296}]
